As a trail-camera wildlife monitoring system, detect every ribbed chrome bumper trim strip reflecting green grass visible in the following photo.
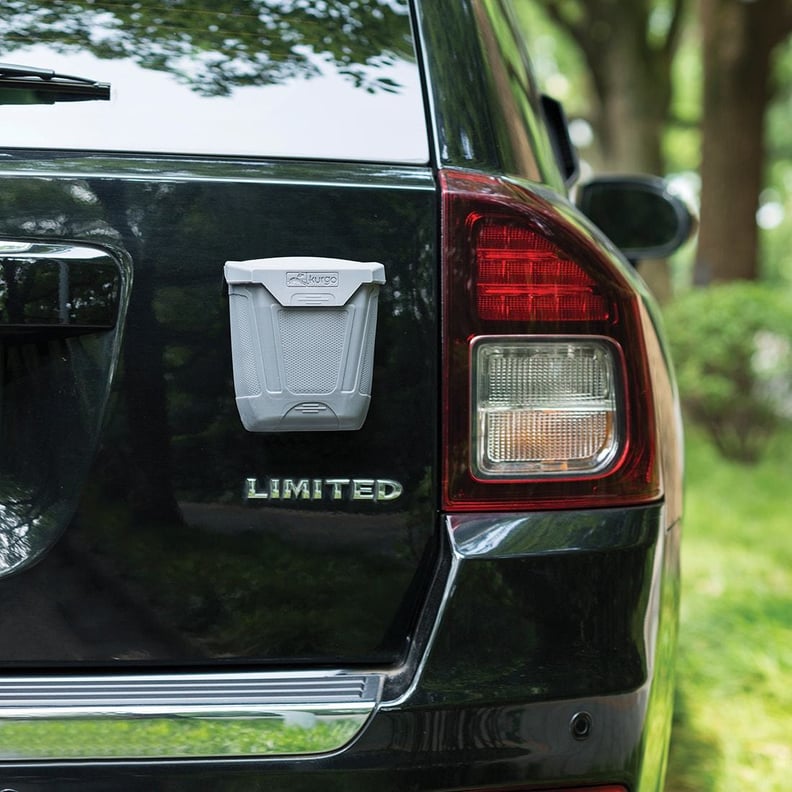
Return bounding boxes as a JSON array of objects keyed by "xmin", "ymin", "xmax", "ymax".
[{"xmin": 0, "ymin": 672, "xmax": 383, "ymax": 761}]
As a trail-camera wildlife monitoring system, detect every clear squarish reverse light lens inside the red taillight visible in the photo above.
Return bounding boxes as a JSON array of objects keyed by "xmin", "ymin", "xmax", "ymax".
[{"xmin": 472, "ymin": 336, "xmax": 620, "ymax": 479}]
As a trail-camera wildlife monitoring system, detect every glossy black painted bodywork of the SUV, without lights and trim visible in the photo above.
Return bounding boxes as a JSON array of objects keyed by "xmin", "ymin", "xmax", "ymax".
[{"xmin": 0, "ymin": 0, "xmax": 681, "ymax": 792}]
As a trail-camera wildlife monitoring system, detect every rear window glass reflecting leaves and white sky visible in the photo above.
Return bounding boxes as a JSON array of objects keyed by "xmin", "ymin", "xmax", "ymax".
[{"xmin": 0, "ymin": 0, "xmax": 429, "ymax": 163}]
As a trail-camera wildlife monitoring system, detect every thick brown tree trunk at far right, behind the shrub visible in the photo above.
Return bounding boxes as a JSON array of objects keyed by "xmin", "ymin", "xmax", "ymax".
[{"xmin": 695, "ymin": 0, "xmax": 792, "ymax": 285}]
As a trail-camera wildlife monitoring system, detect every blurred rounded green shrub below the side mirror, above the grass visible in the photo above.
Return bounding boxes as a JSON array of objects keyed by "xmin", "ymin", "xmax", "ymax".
[{"xmin": 665, "ymin": 281, "xmax": 792, "ymax": 462}]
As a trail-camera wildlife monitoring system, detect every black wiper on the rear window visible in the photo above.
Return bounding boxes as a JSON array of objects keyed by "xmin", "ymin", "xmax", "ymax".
[{"xmin": 0, "ymin": 63, "xmax": 110, "ymax": 104}]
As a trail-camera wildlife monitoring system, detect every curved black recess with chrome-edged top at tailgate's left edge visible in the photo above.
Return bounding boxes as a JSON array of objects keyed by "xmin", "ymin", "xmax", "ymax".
[{"xmin": 0, "ymin": 240, "xmax": 131, "ymax": 578}]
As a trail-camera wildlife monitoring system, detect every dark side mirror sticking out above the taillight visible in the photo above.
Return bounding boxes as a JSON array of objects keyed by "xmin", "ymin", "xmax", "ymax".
[{"xmin": 576, "ymin": 176, "xmax": 697, "ymax": 261}]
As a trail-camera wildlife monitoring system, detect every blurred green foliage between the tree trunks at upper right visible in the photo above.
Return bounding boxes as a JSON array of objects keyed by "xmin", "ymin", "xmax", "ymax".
[{"xmin": 517, "ymin": 0, "xmax": 792, "ymax": 285}]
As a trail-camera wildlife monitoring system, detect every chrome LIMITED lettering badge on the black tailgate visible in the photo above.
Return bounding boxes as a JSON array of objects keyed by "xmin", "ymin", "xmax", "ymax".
[{"xmin": 244, "ymin": 478, "xmax": 404, "ymax": 502}]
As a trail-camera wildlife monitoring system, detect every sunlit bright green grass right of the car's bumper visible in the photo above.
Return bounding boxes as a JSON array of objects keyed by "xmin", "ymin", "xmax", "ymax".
[{"xmin": 666, "ymin": 429, "xmax": 792, "ymax": 792}]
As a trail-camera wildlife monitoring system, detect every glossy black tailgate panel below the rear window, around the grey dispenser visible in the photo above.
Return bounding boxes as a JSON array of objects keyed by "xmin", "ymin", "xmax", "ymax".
[{"xmin": 0, "ymin": 158, "xmax": 438, "ymax": 668}]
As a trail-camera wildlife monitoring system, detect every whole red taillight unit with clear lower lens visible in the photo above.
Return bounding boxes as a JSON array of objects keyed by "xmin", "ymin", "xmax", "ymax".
[{"xmin": 441, "ymin": 171, "xmax": 661, "ymax": 510}]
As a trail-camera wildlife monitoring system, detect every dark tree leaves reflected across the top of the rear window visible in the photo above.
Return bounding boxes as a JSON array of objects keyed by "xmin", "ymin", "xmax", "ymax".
[{"xmin": 0, "ymin": 0, "xmax": 413, "ymax": 96}]
